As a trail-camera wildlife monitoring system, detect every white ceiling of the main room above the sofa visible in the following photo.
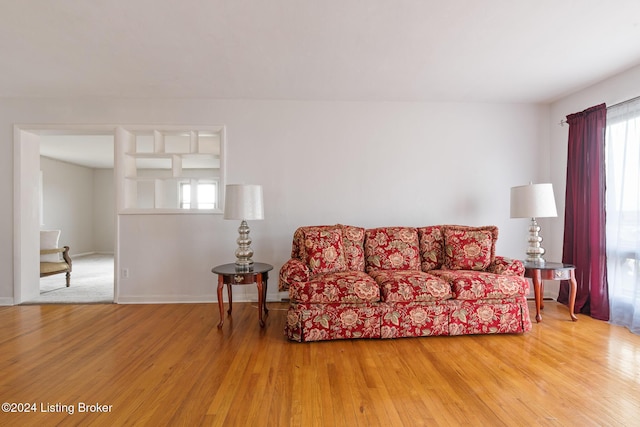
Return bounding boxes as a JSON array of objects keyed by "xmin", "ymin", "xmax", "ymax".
[{"xmin": 0, "ymin": 0, "xmax": 640, "ymax": 103}]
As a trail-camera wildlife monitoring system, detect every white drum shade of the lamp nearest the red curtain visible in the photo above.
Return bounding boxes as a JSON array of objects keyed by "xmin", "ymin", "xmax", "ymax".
[{"xmin": 511, "ymin": 184, "xmax": 558, "ymax": 218}]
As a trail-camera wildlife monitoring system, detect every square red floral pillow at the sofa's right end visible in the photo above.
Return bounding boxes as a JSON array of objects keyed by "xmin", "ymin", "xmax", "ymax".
[{"xmin": 443, "ymin": 225, "xmax": 498, "ymax": 271}]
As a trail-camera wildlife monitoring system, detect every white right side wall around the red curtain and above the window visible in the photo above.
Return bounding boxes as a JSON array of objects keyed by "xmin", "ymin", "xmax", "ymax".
[{"xmin": 542, "ymin": 66, "xmax": 640, "ymax": 298}]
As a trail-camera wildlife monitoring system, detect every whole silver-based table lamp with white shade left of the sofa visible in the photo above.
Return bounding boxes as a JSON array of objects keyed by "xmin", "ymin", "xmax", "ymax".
[{"xmin": 224, "ymin": 184, "xmax": 264, "ymax": 271}]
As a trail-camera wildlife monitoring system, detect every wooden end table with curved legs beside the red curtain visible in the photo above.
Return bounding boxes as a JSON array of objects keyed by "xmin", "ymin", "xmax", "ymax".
[{"xmin": 524, "ymin": 262, "xmax": 578, "ymax": 322}]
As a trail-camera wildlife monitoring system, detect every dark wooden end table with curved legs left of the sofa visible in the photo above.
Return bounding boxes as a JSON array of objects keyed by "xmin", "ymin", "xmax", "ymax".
[{"xmin": 211, "ymin": 262, "xmax": 273, "ymax": 329}]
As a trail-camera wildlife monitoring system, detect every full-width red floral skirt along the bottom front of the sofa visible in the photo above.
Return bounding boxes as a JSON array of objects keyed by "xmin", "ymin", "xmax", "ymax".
[{"xmin": 285, "ymin": 297, "xmax": 532, "ymax": 342}]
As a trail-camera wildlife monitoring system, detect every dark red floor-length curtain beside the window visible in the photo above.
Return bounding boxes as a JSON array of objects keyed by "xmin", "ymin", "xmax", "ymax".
[{"xmin": 558, "ymin": 104, "xmax": 609, "ymax": 320}]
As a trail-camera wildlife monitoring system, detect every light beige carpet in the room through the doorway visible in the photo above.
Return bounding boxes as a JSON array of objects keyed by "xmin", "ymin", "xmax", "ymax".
[{"xmin": 26, "ymin": 254, "xmax": 113, "ymax": 304}]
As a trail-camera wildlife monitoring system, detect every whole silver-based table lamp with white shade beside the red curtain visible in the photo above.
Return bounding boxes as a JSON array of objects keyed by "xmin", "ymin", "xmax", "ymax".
[{"xmin": 511, "ymin": 183, "xmax": 558, "ymax": 264}]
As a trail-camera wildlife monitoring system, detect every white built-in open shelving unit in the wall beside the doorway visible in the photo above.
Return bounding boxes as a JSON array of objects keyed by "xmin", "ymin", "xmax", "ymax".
[{"xmin": 116, "ymin": 126, "xmax": 225, "ymax": 214}]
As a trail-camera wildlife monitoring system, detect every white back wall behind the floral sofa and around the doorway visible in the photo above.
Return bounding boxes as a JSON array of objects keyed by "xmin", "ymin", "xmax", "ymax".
[{"xmin": 0, "ymin": 99, "xmax": 549, "ymax": 302}]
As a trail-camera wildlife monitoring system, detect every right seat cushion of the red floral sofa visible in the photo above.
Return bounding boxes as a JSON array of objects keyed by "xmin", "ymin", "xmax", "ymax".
[{"xmin": 429, "ymin": 270, "xmax": 529, "ymax": 301}]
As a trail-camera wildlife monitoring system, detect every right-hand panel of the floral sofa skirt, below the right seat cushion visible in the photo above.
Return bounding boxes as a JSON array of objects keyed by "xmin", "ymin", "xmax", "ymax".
[{"xmin": 449, "ymin": 298, "xmax": 531, "ymax": 335}]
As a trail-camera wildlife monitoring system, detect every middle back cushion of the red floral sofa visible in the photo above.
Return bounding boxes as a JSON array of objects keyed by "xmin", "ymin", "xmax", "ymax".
[{"xmin": 364, "ymin": 227, "xmax": 420, "ymax": 272}]
